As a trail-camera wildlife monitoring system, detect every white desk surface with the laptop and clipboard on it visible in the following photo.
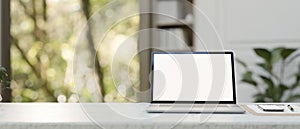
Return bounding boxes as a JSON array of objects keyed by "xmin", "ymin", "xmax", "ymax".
[{"xmin": 0, "ymin": 103, "xmax": 300, "ymax": 129}]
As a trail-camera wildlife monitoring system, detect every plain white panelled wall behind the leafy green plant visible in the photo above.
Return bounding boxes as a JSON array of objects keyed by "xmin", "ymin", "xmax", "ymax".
[{"xmin": 194, "ymin": 0, "xmax": 300, "ymax": 102}]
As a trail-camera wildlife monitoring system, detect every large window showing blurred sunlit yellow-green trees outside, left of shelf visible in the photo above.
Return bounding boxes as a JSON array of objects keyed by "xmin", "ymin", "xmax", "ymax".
[{"xmin": 6, "ymin": 0, "xmax": 139, "ymax": 102}]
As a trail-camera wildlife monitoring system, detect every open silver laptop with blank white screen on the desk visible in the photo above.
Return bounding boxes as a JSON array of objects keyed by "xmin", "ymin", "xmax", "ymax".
[{"xmin": 146, "ymin": 51, "xmax": 245, "ymax": 113}]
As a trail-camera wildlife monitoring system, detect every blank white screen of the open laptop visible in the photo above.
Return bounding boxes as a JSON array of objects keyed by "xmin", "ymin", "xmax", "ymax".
[{"xmin": 152, "ymin": 52, "xmax": 235, "ymax": 102}]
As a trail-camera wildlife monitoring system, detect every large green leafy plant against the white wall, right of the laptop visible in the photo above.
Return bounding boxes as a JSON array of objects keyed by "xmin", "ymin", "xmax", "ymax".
[{"xmin": 237, "ymin": 47, "xmax": 300, "ymax": 102}]
